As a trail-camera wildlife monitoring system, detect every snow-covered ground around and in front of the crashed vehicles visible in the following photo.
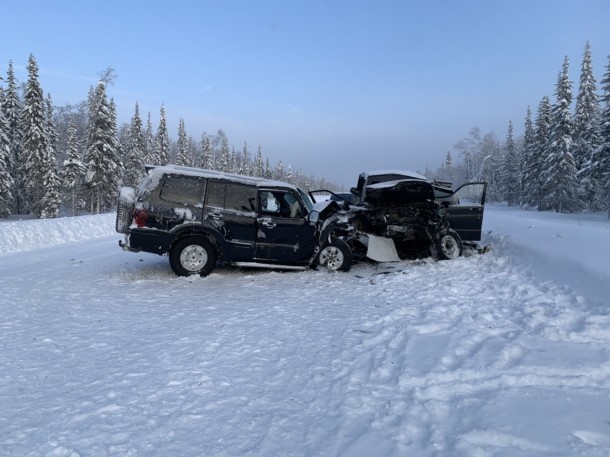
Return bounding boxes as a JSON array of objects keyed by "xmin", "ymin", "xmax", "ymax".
[{"xmin": 0, "ymin": 207, "xmax": 610, "ymax": 457}]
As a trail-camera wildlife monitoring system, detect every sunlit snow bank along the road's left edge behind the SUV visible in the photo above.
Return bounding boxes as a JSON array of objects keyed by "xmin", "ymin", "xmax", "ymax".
[{"xmin": 0, "ymin": 213, "xmax": 116, "ymax": 254}]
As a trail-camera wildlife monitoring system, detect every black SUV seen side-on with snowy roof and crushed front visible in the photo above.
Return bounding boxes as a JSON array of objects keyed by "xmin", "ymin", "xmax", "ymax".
[{"xmin": 116, "ymin": 165, "xmax": 352, "ymax": 276}]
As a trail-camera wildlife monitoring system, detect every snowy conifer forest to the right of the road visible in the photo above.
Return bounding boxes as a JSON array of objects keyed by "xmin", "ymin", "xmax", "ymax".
[{"xmin": 430, "ymin": 43, "xmax": 610, "ymax": 212}]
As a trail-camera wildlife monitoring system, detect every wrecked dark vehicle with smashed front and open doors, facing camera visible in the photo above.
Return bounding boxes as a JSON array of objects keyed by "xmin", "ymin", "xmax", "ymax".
[{"xmin": 312, "ymin": 170, "xmax": 487, "ymax": 262}]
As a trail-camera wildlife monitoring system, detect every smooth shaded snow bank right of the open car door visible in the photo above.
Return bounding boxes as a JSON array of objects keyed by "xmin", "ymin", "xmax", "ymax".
[{"xmin": 483, "ymin": 205, "xmax": 610, "ymax": 303}]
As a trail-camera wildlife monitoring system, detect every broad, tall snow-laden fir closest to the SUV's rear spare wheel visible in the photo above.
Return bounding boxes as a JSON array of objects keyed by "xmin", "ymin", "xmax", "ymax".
[{"xmin": 84, "ymin": 79, "xmax": 123, "ymax": 213}]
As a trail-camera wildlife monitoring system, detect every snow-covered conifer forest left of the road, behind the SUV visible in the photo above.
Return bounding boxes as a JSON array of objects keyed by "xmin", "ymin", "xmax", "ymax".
[{"xmin": 0, "ymin": 55, "xmax": 336, "ymax": 218}]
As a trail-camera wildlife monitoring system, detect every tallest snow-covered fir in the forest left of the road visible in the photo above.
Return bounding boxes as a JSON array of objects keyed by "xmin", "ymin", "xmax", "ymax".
[{"xmin": 20, "ymin": 54, "xmax": 48, "ymax": 217}]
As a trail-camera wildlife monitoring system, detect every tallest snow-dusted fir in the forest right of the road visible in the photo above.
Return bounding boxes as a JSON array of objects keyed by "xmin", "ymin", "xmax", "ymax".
[{"xmin": 573, "ymin": 42, "xmax": 602, "ymax": 208}]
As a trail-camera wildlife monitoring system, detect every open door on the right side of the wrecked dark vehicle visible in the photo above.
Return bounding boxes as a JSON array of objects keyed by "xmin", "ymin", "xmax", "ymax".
[{"xmin": 445, "ymin": 182, "xmax": 487, "ymax": 241}]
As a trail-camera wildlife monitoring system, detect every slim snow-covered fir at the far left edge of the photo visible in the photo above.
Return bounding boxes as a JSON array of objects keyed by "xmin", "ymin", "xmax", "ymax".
[{"xmin": 1, "ymin": 62, "xmax": 22, "ymax": 214}]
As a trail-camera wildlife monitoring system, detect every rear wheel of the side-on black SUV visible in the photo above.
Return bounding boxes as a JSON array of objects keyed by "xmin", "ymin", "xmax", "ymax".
[{"xmin": 169, "ymin": 236, "xmax": 217, "ymax": 276}]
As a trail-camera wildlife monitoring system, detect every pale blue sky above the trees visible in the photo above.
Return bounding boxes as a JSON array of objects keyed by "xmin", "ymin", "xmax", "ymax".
[{"xmin": 0, "ymin": 0, "xmax": 610, "ymax": 186}]
